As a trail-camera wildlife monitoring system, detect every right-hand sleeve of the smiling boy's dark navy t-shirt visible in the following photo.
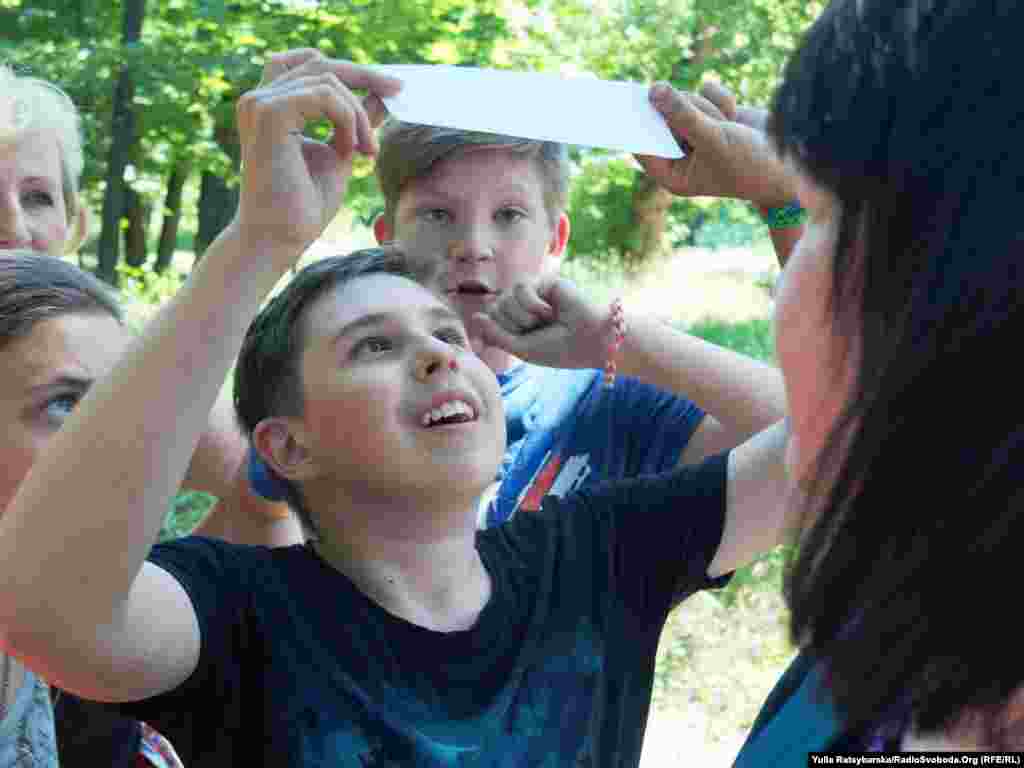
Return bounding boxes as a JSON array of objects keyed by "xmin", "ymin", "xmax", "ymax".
[{"xmin": 545, "ymin": 453, "xmax": 730, "ymax": 616}]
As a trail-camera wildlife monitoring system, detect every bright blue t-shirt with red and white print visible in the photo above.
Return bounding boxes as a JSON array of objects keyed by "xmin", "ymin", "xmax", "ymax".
[{"xmin": 479, "ymin": 362, "xmax": 705, "ymax": 527}]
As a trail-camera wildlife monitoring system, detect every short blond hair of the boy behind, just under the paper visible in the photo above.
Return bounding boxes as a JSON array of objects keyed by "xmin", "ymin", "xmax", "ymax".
[{"xmin": 376, "ymin": 119, "xmax": 569, "ymax": 227}]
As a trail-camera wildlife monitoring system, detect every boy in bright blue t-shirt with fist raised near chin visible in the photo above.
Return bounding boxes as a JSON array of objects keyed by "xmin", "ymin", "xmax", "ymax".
[{"xmin": 375, "ymin": 83, "xmax": 785, "ymax": 527}]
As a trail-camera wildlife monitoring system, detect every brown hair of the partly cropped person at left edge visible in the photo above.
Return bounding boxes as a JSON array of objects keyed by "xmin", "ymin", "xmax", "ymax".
[{"xmin": 0, "ymin": 249, "xmax": 123, "ymax": 347}]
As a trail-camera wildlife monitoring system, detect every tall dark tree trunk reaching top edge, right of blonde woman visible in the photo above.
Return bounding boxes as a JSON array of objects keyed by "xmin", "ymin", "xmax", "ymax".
[{"xmin": 96, "ymin": 0, "xmax": 145, "ymax": 285}]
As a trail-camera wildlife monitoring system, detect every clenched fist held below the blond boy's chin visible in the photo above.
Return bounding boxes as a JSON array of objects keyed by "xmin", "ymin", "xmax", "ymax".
[{"xmin": 469, "ymin": 274, "xmax": 611, "ymax": 368}]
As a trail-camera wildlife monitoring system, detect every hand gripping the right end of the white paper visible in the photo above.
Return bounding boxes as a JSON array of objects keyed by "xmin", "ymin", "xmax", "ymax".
[{"xmin": 637, "ymin": 83, "xmax": 796, "ymax": 207}]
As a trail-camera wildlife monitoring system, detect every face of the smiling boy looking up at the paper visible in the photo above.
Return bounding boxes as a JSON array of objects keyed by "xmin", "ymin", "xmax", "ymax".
[{"xmin": 260, "ymin": 273, "xmax": 505, "ymax": 532}]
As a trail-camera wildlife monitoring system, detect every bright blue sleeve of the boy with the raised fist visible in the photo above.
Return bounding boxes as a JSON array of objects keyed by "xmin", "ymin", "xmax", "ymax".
[{"xmin": 613, "ymin": 377, "xmax": 705, "ymax": 477}]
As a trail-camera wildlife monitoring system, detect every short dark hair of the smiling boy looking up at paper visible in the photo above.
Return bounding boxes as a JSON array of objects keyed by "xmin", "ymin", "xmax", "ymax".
[{"xmin": 234, "ymin": 246, "xmax": 426, "ymax": 532}]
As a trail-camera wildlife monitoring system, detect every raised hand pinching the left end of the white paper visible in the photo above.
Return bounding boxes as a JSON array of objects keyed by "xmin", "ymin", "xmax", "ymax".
[{"xmin": 237, "ymin": 48, "xmax": 401, "ymax": 264}]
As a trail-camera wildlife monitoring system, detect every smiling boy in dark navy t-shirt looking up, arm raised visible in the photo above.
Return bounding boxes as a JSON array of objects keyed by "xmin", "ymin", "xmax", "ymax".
[{"xmin": 0, "ymin": 51, "xmax": 795, "ymax": 768}]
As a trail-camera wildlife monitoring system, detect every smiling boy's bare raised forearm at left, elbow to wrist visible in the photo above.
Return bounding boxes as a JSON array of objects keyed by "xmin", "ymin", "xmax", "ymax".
[{"xmin": 0, "ymin": 227, "xmax": 276, "ymax": 652}]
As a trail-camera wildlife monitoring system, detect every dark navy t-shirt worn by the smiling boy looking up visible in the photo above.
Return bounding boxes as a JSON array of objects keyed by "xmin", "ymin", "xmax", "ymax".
[{"xmin": 119, "ymin": 455, "xmax": 727, "ymax": 768}]
